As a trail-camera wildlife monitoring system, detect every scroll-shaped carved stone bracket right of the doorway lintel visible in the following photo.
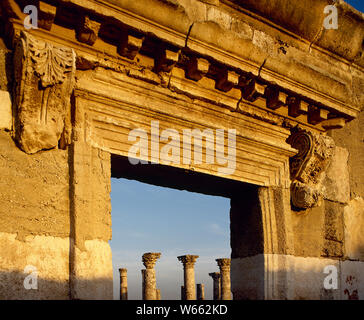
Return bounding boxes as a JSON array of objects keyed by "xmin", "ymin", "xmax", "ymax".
[{"xmin": 287, "ymin": 128, "xmax": 335, "ymax": 209}]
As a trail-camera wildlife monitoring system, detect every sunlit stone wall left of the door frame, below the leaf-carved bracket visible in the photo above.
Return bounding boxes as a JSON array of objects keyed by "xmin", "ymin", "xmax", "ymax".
[{"xmin": 0, "ymin": 130, "xmax": 70, "ymax": 299}]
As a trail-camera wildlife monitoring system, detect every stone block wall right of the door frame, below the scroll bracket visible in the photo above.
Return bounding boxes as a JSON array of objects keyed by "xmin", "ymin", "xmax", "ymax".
[{"xmin": 292, "ymin": 112, "xmax": 364, "ymax": 299}]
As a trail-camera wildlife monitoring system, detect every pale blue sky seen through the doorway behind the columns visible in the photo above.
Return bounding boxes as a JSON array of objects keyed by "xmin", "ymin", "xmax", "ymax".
[{"xmin": 110, "ymin": 0, "xmax": 364, "ymax": 299}]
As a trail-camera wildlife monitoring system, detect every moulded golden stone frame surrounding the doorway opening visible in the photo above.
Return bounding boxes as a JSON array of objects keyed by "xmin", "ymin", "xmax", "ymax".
[{"xmin": 67, "ymin": 69, "xmax": 296, "ymax": 299}]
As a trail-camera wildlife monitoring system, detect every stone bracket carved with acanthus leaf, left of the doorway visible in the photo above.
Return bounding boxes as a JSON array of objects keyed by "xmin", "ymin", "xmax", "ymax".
[{"xmin": 14, "ymin": 32, "xmax": 76, "ymax": 153}]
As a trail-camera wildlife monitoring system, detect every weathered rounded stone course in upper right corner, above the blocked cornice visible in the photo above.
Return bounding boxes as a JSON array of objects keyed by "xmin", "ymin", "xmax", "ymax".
[{"xmin": 228, "ymin": 0, "xmax": 364, "ymax": 67}]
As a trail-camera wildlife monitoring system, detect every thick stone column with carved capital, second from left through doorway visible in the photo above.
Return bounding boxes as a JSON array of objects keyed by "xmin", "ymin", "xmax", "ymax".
[{"xmin": 143, "ymin": 252, "xmax": 161, "ymax": 300}]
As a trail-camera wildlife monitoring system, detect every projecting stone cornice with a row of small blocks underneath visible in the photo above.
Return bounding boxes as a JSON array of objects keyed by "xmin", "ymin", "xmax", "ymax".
[{"xmin": 2, "ymin": 0, "xmax": 359, "ymax": 130}]
